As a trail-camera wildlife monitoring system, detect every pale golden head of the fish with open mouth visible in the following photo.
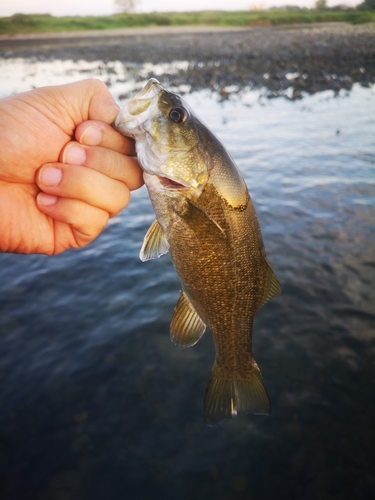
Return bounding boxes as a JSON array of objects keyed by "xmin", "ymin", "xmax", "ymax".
[{"xmin": 115, "ymin": 78, "xmax": 210, "ymax": 196}]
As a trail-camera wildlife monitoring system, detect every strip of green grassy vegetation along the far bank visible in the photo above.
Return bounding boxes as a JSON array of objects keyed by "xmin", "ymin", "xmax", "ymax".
[{"xmin": 0, "ymin": 9, "xmax": 375, "ymax": 34}]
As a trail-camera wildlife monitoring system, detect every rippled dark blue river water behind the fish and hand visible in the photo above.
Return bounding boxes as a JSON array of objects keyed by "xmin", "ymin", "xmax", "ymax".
[{"xmin": 0, "ymin": 59, "xmax": 375, "ymax": 500}]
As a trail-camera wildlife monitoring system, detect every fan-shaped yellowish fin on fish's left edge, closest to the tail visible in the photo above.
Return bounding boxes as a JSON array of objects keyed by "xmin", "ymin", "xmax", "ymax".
[{"xmin": 170, "ymin": 292, "xmax": 206, "ymax": 347}]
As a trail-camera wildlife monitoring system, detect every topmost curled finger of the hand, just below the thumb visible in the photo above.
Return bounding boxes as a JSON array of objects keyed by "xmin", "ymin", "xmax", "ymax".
[{"xmin": 75, "ymin": 120, "xmax": 135, "ymax": 156}]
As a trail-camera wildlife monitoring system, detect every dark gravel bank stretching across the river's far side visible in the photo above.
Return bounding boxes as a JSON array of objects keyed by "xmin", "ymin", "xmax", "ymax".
[{"xmin": 0, "ymin": 23, "xmax": 375, "ymax": 98}]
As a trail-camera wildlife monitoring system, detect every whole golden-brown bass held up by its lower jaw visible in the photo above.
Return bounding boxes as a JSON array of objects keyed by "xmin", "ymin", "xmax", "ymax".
[{"xmin": 115, "ymin": 78, "xmax": 281, "ymax": 425}]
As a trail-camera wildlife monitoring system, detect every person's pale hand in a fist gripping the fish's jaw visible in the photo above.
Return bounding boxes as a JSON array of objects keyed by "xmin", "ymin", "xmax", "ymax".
[{"xmin": 0, "ymin": 80, "xmax": 143, "ymax": 255}]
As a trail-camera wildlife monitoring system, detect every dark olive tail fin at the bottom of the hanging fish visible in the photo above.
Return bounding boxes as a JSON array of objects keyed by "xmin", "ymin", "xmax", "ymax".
[{"xmin": 204, "ymin": 362, "xmax": 271, "ymax": 425}]
